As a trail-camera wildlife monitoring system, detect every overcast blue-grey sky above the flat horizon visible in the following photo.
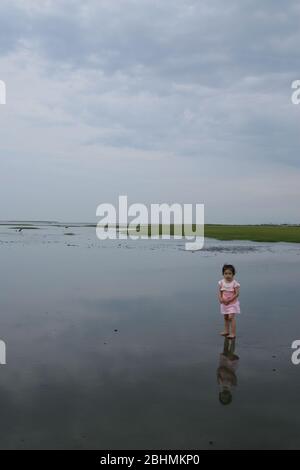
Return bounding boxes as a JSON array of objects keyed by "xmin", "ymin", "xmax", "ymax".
[{"xmin": 0, "ymin": 0, "xmax": 300, "ymax": 223}]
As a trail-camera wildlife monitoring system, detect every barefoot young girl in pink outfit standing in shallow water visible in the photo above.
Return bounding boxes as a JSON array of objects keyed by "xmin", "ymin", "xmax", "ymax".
[{"xmin": 218, "ymin": 264, "xmax": 240, "ymax": 339}]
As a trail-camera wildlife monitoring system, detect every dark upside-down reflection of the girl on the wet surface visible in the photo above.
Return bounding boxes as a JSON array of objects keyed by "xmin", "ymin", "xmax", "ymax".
[{"xmin": 217, "ymin": 338, "xmax": 239, "ymax": 405}]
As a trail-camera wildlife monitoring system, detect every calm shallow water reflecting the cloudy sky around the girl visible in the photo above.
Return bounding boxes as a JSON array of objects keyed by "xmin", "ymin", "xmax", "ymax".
[{"xmin": 0, "ymin": 226, "xmax": 300, "ymax": 450}]
